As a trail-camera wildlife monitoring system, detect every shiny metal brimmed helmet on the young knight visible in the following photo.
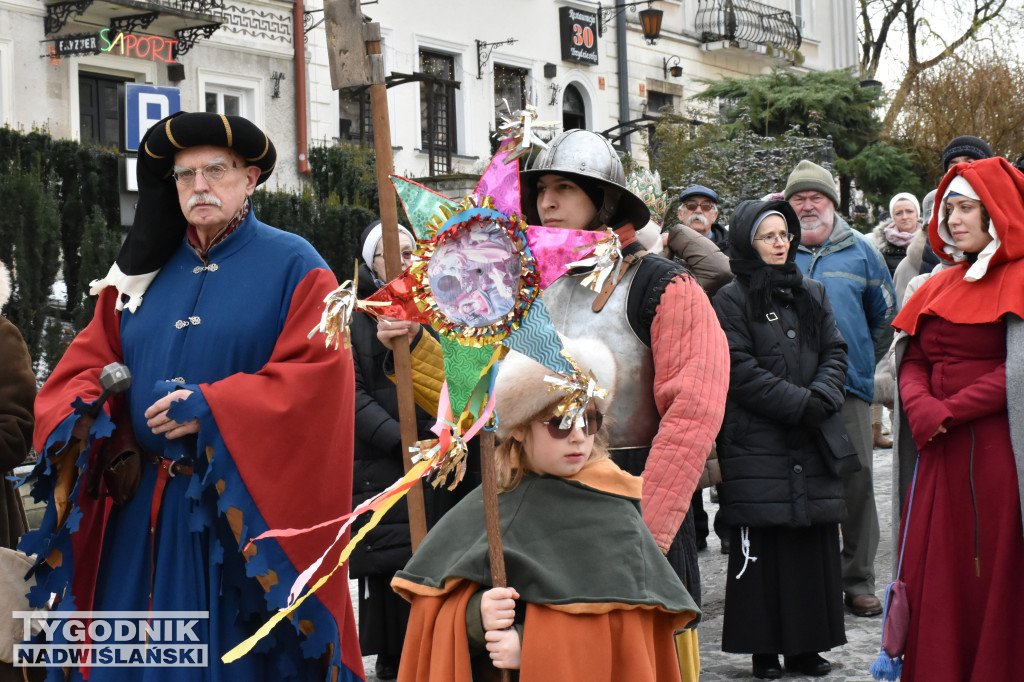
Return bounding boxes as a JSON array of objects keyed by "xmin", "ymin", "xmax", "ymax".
[{"xmin": 519, "ymin": 129, "xmax": 650, "ymax": 229}]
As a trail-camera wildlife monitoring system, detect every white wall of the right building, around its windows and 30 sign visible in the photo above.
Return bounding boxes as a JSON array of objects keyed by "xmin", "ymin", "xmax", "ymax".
[{"xmin": 309, "ymin": 0, "xmax": 856, "ymax": 177}]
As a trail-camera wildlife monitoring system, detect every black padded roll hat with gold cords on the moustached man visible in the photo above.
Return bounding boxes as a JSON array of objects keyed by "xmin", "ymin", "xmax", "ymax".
[{"xmin": 138, "ymin": 112, "xmax": 278, "ymax": 184}]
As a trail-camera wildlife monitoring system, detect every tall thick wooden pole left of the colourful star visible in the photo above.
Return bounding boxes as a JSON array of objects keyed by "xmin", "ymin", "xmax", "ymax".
[{"xmin": 364, "ymin": 24, "xmax": 427, "ymax": 552}]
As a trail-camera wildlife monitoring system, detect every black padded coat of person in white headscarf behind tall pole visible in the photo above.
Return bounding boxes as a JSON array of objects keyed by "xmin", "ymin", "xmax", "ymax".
[{"xmin": 349, "ymin": 264, "xmax": 452, "ymax": 578}]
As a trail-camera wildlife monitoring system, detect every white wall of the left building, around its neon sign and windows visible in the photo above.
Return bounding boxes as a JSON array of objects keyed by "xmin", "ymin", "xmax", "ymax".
[{"xmin": 0, "ymin": 0, "xmax": 305, "ymax": 188}]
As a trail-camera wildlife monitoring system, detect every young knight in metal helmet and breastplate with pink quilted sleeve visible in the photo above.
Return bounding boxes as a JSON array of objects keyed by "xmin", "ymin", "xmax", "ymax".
[{"xmin": 520, "ymin": 130, "xmax": 729, "ymax": 649}]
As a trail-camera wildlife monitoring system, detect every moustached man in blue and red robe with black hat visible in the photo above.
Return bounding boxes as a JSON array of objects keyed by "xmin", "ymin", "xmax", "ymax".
[{"xmin": 20, "ymin": 112, "xmax": 365, "ymax": 682}]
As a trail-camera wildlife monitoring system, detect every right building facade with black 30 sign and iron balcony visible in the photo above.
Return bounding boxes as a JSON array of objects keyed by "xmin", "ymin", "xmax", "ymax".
[{"xmin": 309, "ymin": 0, "xmax": 857, "ymax": 178}]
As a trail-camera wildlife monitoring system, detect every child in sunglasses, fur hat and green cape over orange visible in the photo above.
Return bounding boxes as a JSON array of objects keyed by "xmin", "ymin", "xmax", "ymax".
[{"xmin": 391, "ymin": 339, "xmax": 699, "ymax": 682}]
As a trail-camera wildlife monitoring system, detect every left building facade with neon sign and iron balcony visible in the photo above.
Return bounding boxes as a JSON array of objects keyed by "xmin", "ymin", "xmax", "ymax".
[{"xmin": 0, "ymin": 0, "xmax": 309, "ymax": 187}]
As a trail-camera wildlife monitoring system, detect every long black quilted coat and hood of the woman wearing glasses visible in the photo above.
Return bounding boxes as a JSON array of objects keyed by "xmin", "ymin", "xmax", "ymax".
[{"xmin": 713, "ymin": 202, "xmax": 847, "ymax": 527}]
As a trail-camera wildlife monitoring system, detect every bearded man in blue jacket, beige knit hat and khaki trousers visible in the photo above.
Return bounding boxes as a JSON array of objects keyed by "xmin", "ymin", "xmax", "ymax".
[{"xmin": 785, "ymin": 160, "xmax": 896, "ymax": 616}]
